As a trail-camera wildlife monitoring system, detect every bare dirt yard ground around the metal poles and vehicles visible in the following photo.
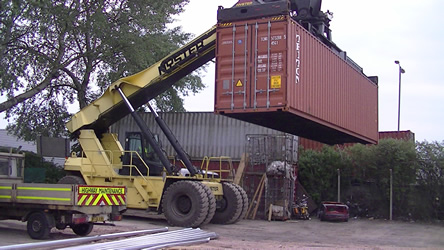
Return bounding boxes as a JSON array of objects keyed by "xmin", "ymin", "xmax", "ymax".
[{"xmin": 0, "ymin": 213, "xmax": 444, "ymax": 249}]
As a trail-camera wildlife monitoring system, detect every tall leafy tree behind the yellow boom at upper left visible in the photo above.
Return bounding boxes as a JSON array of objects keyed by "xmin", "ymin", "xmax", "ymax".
[{"xmin": 0, "ymin": 0, "xmax": 204, "ymax": 140}]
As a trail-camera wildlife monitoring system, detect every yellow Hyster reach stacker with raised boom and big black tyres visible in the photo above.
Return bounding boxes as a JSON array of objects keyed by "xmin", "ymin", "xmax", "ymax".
[{"xmin": 59, "ymin": 23, "xmax": 248, "ymax": 227}]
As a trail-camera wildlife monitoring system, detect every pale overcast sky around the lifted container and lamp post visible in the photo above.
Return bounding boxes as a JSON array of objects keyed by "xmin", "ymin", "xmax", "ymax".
[{"xmin": 0, "ymin": 0, "xmax": 444, "ymax": 142}]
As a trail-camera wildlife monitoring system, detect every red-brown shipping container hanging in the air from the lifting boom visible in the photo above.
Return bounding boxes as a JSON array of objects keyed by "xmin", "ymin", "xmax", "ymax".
[{"xmin": 215, "ymin": 16, "xmax": 378, "ymax": 144}]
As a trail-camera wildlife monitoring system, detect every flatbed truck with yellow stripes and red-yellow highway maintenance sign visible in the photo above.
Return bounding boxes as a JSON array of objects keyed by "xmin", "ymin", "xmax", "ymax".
[{"xmin": 0, "ymin": 150, "xmax": 126, "ymax": 239}]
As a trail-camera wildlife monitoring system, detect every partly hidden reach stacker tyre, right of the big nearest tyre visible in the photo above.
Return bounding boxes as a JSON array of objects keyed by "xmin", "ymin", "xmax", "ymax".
[{"xmin": 211, "ymin": 182, "xmax": 243, "ymax": 224}]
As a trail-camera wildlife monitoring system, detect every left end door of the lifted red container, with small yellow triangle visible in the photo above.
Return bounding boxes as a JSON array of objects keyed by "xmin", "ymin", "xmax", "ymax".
[{"xmin": 216, "ymin": 23, "xmax": 250, "ymax": 110}]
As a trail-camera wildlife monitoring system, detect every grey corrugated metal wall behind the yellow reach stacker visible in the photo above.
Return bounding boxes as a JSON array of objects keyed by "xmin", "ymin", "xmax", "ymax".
[{"xmin": 111, "ymin": 112, "xmax": 294, "ymax": 160}]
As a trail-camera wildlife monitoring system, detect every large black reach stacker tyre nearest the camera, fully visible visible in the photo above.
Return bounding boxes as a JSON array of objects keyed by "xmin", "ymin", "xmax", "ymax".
[{"xmin": 162, "ymin": 181, "xmax": 209, "ymax": 227}]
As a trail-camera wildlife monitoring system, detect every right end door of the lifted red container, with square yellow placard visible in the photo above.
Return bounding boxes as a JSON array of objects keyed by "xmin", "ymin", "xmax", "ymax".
[{"xmin": 250, "ymin": 18, "xmax": 288, "ymax": 109}]
